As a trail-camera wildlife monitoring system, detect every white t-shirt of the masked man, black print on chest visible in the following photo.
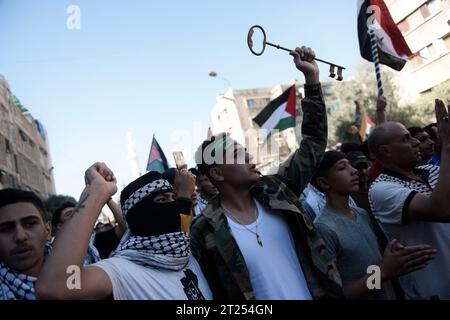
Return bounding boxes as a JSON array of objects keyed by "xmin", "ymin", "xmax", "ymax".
[{"xmin": 93, "ymin": 252, "xmax": 212, "ymax": 300}]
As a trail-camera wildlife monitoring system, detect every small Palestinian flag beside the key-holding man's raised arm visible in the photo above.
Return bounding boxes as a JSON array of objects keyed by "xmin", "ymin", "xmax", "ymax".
[{"xmin": 253, "ymin": 85, "xmax": 297, "ymax": 136}]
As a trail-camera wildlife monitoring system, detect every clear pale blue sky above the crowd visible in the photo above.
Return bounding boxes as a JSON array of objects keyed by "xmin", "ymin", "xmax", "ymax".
[{"xmin": 0, "ymin": 0, "xmax": 361, "ymax": 198}]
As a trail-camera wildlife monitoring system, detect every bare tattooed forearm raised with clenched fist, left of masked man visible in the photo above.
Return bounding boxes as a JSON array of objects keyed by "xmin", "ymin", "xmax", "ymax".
[{"xmin": 36, "ymin": 163, "xmax": 117, "ymax": 299}]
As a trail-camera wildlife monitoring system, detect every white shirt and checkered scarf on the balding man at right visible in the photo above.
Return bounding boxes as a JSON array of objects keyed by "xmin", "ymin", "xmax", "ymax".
[{"xmin": 369, "ymin": 165, "xmax": 450, "ymax": 299}]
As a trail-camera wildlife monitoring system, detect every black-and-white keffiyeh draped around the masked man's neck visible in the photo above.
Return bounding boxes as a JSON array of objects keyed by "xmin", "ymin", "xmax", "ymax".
[{"xmin": 112, "ymin": 232, "xmax": 190, "ymax": 271}]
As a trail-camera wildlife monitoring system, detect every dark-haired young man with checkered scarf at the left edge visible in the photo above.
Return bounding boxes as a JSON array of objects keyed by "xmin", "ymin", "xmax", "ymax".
[{"xmin": 0, "ymin": 189, "xmax": 51, "ymax": 300}]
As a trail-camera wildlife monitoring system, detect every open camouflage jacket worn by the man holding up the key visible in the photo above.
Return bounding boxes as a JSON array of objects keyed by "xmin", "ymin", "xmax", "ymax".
[{"xmin": 191, "ymin": 85, "xmax": 343, "ymax": 300}]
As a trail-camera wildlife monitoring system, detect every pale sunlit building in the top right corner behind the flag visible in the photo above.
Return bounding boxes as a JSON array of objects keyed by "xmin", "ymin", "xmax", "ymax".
[{"xmin": 385, "ymin": 0, "xmax": 450, "ymax": 100}]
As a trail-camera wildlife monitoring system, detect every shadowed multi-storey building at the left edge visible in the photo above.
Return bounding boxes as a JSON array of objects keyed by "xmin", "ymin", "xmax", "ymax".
[{"xmin": 0, "ymin": 75, "xmax": 55, "ymax": 199}]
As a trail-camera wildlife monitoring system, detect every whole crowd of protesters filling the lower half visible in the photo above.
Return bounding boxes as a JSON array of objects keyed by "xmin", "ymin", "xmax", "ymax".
[{"xmin": 0, "ymin": 47, "xmax": 450, "ymax": 300}]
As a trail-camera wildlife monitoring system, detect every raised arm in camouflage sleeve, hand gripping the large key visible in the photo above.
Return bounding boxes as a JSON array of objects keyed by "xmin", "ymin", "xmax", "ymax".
[{"xmin": 278, "ymin": 47, "xmax": 328, "ymax": 196}]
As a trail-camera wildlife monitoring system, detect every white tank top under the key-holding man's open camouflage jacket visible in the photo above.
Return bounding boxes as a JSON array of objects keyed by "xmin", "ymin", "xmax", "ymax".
[{"xmin": 227, "ymin": 201, "xmax": 312, "ymax": 300}]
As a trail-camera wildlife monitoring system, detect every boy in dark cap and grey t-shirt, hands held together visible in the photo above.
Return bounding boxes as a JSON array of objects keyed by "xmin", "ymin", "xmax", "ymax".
[{"xmin": 311, "ymin": 151, "xmax": 436, "ymax": 299}]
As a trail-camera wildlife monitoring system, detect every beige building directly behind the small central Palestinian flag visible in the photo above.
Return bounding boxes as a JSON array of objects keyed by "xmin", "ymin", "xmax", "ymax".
[{"xmin": 211, "ymin": 83, "xmax": 339, "ymax": 174}]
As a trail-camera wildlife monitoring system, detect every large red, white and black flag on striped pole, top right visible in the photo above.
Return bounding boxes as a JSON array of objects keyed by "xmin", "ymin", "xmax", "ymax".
[{"xmin": 358, "ymin": 0, "xmax": 413, "ymax": 71}]
